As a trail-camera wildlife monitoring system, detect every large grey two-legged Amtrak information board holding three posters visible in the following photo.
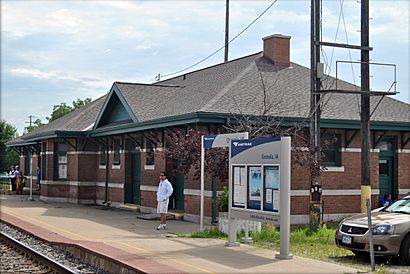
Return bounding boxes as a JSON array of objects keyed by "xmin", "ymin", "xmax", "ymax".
[{"xmin": 225, "ymin": 137, "xmax": 292, "ymax": 259}]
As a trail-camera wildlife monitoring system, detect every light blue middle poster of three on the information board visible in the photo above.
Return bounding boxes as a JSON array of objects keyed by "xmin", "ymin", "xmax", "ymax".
[{"xmin": 248, "ymin": 166, "xmax": 262, "ymax": 209}]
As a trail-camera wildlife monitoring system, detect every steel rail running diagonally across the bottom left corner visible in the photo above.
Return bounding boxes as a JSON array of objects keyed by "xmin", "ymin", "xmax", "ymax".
[{"xmin": 0, "ymin": 232, "xmax": 77, "ymax": 274}]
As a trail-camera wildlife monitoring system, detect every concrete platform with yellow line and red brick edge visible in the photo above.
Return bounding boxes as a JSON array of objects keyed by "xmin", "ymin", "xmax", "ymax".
[{"xmin": 0, "ymin": 195, "xmax": 359, "ymax": 274}]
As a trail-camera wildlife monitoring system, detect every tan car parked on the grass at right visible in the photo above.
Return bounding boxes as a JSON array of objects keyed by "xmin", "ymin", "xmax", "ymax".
[{"xmin": 335, "ymin": 195, "xmax": 410, "ymax": 265}]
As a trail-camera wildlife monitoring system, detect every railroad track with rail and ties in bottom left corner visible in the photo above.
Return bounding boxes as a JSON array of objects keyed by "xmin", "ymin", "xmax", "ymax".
[{"xmin": 0, "ymin": 232, "xmax": 78, "ymax": 274}]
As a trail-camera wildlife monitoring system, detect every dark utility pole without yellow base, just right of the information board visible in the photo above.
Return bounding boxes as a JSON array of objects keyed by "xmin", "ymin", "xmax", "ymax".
[{"xmin": 309, "ymin": 0, "xmax": 323, "ymax": 227}]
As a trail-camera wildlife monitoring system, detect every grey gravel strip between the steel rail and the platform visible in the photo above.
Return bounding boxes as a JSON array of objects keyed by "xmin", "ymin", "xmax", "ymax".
[{"xmin": 0, "ymin": 223, "xmax": 109, "ymax": 274}]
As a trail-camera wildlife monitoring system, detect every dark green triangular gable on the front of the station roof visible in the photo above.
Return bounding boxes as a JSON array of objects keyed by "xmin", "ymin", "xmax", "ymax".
[{"xmin": 93, "ymin": 83, "xmax": 138, "ymax": 129}]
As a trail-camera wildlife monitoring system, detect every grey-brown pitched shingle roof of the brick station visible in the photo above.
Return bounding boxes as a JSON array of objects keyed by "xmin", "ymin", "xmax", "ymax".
[{"xmin": 8, "ymin": 52, "xmax": 410, "ymax": 144}]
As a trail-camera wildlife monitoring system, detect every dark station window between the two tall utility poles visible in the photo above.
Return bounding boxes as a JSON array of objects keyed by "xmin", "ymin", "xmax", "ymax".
[{"xmin": 322, "ymin": 134, "xmax": 342, "ymax": 166}]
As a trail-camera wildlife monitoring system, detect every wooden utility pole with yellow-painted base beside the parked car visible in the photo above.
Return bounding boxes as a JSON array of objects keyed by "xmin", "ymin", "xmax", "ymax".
[{"xmin": 360, "ymin": 0, "xmax": 371, "ymax": 213}]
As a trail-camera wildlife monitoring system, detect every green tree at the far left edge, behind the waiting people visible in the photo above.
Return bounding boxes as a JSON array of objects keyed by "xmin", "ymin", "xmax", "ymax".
[{"xmin": 0, "ymin": 120, "xmax": 19, "ymax": 172}]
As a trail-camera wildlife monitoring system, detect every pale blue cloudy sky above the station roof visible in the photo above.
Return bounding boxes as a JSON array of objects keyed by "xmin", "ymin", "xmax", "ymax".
[{"xmin": 0, "ymin": 0, "xmax": 410, "ymax": 134}]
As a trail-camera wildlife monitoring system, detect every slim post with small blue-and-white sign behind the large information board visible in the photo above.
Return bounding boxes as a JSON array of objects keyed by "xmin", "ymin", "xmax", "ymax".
[{"xmin": 199, "ymin": 132, "xmax": 248, "ymax": 232}]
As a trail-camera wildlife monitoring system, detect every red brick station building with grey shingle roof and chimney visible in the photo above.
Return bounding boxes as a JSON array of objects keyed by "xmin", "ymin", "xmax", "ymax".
[{"xmin": 8, "ymin": 35, "xmax": 410, "ymax": 224}]
